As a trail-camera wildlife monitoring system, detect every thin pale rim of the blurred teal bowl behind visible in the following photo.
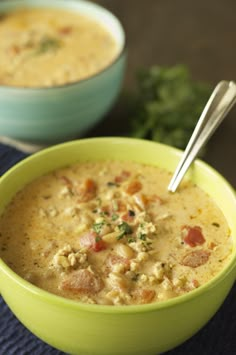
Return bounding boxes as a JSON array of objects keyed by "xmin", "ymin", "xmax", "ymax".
[{"xmin": 0, "ymin": 0, "xmax": 127, "ymax": 92}]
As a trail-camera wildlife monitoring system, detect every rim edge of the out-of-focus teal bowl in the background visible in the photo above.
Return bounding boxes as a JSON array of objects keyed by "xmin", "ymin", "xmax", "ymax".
[{"xmin": 0, "ymin": 0, "xmax": 127, "ymax": 92}]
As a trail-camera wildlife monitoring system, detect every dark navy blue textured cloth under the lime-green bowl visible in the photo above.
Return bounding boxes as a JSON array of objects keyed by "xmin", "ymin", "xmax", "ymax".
[{"xmin": 0, "ymin": 144, "xmax": 236, "ymax": 355}]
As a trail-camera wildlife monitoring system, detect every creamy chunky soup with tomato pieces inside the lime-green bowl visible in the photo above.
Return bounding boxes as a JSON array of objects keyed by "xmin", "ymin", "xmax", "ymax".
[{"xmin": 0, "ymin": 161, "xmax": 232, "ymax": 305}]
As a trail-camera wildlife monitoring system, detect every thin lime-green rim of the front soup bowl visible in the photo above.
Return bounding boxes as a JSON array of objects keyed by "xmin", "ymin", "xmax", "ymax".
[{"xmin": 0, "ymin": 137, "xmax": 236, "ymax": 316}]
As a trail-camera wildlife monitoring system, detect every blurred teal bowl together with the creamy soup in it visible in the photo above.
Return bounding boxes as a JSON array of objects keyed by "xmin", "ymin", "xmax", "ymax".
[{"xmin": 0, "ymin": 0, "xmax": 126, "ymax": 144}]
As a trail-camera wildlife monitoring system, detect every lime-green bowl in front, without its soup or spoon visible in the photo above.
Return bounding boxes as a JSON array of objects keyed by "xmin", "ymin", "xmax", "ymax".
[{"xmin": 0, "ymin": 138, "xmax": 236, "ymax": 355}]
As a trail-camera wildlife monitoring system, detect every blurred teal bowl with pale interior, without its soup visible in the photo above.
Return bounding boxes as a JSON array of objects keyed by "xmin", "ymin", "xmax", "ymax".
[{"xmin": 0, "ymin": 0, "xmax": 126, "ymax": 144}]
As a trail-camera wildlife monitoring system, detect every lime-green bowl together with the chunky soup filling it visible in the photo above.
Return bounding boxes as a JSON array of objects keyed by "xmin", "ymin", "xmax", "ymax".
[{"xmin": 0, "ymin": 138, "xmax": 236, "ymax": 355}]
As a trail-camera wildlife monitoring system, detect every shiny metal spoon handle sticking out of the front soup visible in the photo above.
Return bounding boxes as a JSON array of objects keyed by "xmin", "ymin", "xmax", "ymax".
[{"xmin": 168, "ymin": 81, "xmax": 236, "ymax": 192}]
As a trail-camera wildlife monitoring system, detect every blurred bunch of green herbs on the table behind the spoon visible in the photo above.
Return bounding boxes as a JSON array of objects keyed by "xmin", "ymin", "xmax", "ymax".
[{"xmin": 130, "ymin": 65, "xmax": 212, "ymax": 149}]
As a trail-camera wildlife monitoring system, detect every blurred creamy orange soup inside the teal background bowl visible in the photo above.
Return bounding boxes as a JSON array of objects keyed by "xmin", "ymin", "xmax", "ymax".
[{"xmin": 0, "ymin": 8, "xmax": 119, "ymax": 87}]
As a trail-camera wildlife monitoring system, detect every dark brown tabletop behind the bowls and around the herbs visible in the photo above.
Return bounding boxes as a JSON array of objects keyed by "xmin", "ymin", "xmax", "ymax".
[{"xmin": 90, "ymin": 0, "xmax": 236, "ymax": 187}]
